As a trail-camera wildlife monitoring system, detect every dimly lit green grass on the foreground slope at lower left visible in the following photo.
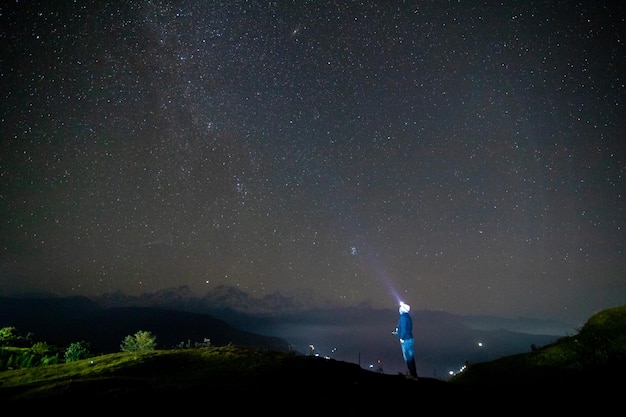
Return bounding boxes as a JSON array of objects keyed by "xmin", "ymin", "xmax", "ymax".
[{"xmin": 0, "ymin": 346, "xmax": 278, "ymax": 400}]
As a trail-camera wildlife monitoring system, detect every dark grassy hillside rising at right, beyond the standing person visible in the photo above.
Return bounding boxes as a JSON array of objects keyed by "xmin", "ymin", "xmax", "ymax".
[{"xmin": 450, "ymin": 305, "xmax": 626, "ymax": 395}]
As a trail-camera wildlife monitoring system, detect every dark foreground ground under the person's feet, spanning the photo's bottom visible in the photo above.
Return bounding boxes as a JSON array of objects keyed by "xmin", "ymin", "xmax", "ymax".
[{"xmin": 0, "ymin": 347, "xmax": 621, "ymax": 416}]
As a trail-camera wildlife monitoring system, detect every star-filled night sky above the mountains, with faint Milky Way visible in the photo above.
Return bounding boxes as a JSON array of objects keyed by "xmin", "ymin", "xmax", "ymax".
[{"xmin": 0, "ymin": 0, "xmax": 626, "ymax": 322}]
